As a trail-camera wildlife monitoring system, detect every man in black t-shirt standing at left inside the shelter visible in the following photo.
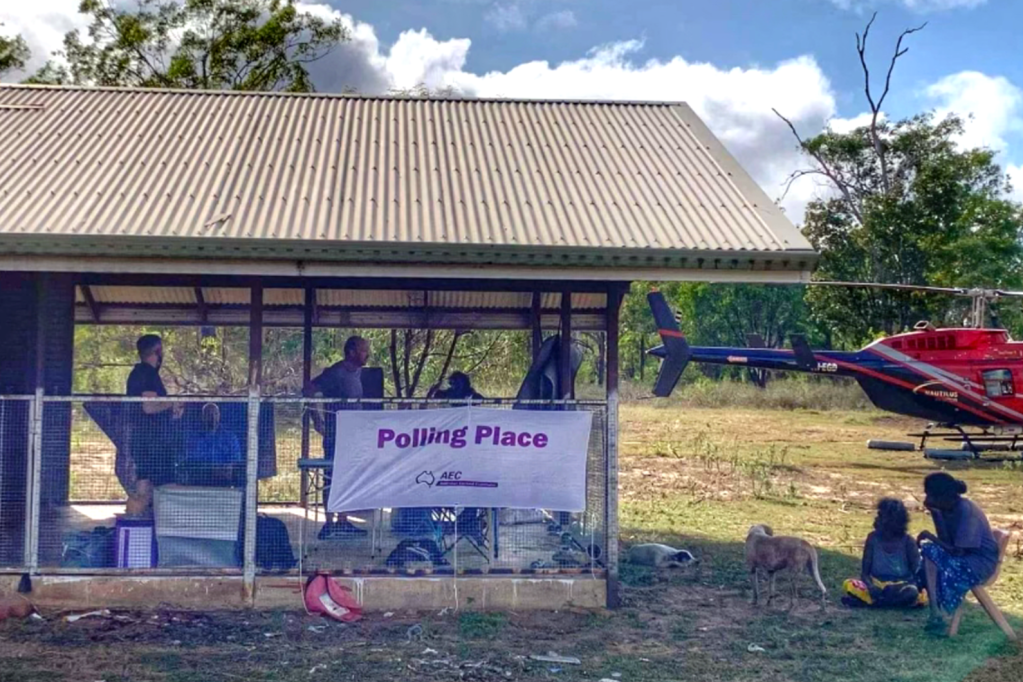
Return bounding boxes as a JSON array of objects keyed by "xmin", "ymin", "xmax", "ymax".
[{"xmin": 126, "ymin": 334, "xmax": 184, "ymax": 508}]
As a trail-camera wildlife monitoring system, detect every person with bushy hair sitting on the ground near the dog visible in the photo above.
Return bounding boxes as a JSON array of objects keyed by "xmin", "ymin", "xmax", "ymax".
[{"xmin": 842, "ymin": 498, "xmax": 927, "ymax": 608}]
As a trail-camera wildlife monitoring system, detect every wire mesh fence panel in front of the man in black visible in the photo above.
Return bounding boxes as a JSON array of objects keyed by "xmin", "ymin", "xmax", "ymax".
[{"xmin": 38, "ymin": 397, "xmax": 257, "ymax": 572}]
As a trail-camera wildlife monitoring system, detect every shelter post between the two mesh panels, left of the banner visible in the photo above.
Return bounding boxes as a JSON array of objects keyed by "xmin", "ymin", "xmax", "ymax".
[{"xmin": 242, "ymin": 282, "xmax": 263, "ymax": 606}]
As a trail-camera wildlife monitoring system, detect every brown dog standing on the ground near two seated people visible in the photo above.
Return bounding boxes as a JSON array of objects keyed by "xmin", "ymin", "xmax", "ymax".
[{"xmin": 746, "ymin": 526, "xmax": 828, "ymax": 610}]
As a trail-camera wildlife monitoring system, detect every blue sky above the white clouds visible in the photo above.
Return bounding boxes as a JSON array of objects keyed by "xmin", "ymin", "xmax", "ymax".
[{"xmin": 345, "ymin": 0, "xmax": 1023, "ymax": 110}]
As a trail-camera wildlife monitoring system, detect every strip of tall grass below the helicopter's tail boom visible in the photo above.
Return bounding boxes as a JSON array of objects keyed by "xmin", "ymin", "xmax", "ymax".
[{"xmin": 622, "ymin": 378, "xmax": 872, "ymax": 411}]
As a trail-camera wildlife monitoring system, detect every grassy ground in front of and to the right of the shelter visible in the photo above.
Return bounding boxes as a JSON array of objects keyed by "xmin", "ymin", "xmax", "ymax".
[{"xmin": 7, "ymin": 401, "xmax": 1023, "ymax": 682}]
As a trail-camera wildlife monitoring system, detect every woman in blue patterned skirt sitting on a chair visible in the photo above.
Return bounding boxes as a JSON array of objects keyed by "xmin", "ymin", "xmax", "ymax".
[{"xmin": 917, "ymin": 471, "xmax": 998, "ymax": 634}]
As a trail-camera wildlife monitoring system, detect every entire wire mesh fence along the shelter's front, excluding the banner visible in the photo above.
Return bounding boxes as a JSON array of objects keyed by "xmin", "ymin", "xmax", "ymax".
[{"xmin": 0, "ymin": 396, "xmax": 609, "ymax": 575}]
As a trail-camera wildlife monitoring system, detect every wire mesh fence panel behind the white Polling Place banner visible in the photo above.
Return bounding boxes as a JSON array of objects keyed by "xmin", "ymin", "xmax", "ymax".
[{"xmin": 256, "ymin": 400, "xmax": 607, "ymax": 575}]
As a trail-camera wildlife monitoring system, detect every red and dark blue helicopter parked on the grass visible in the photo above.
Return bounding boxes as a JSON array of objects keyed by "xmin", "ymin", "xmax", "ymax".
[{"xmin": 648, "ymin": 282, "xmax": 1023, "ymax": 459}]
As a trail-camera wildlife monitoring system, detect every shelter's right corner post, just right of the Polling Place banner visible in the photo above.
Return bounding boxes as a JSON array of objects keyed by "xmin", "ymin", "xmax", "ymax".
[{"xmin": 604, "ymin": 285, "xmax": 624, "ymax": 608}]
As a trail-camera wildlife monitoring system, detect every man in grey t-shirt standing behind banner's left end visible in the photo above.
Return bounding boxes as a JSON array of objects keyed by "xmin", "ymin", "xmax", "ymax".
[{"xmin": 306, "ymin": 336, "xmax": 369, "ymax": 540}]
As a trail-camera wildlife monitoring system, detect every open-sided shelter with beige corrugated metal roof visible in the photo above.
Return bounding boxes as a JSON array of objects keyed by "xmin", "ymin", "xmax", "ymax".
[{"xmin": 0, "ymin": 86, "xmax": 816, "ymax": 608}]
